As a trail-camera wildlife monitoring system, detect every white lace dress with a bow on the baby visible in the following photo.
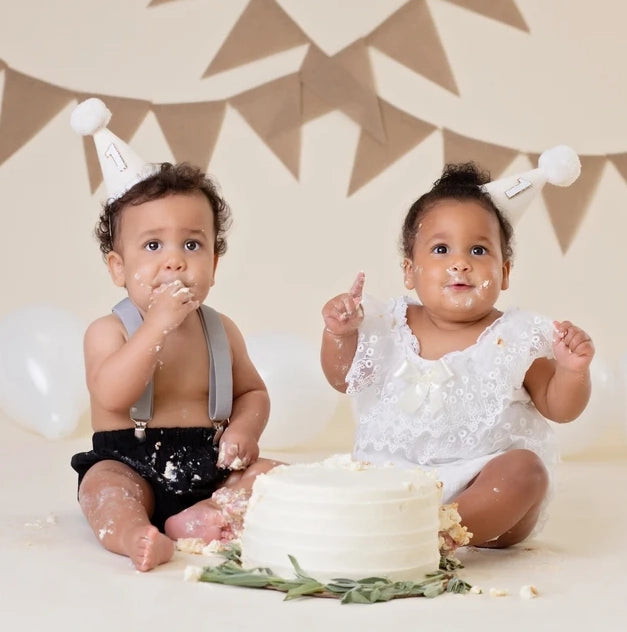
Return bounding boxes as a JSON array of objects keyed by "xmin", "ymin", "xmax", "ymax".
[{"xmin": 346, "ymin": 296, "xmax": 557, "ymax": 503}]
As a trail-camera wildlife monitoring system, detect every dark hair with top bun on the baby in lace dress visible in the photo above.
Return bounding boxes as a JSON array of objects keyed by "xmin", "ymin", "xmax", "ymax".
[{"xmin": 400, "ymin": 162, "xmax": 514, "ymax": 261}]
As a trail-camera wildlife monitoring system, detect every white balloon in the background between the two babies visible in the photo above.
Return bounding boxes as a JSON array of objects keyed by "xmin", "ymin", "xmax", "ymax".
[{"xmin": 246, "ymin": 333, "xmax": 339, "ymax": 450}]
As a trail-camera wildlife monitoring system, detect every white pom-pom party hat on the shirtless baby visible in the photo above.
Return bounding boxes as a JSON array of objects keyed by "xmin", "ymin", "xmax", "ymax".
[{"xmin": 70, "ymin": 98, "xmax": 159, "ymax": 200}]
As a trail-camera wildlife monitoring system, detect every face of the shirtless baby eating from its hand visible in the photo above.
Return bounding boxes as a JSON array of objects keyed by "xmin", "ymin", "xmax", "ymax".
[{"xmin": 107, "ymin": 193, "xmax": 217, "ymax": 311}]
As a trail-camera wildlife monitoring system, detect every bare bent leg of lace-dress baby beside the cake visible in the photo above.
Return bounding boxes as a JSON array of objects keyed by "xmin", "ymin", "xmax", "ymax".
[{"xmin": 453, "ymin": 450, "xmax": 548, "ymax": 548}]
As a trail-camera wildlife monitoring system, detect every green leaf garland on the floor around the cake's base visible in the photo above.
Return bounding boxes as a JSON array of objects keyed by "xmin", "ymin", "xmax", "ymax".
[{"xmin": 198, "ymin": 543, "xmax": 471, "ymax": 604}]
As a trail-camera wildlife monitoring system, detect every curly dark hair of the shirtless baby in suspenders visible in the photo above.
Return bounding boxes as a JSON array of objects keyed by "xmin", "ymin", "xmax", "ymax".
[{"xmin": 94, "ymin": 162, "xmax": 231, "ymax": 256}]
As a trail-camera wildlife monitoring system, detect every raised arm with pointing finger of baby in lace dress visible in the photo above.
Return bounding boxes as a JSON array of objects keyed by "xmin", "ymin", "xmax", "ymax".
[{"xmin": 320, "ymin": 272, "xmax": 366, "ymax": 393}]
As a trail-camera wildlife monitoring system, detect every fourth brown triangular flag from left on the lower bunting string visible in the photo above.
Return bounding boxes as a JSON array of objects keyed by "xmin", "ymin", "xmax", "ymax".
[{"xmin": 229, "ymin": 73, "xmax": 301, "ymax": 178}]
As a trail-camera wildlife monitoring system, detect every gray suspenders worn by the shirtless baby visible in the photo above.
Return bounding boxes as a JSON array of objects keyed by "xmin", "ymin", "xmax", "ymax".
[{"xmin": 113, "ymin": 297, "xmax": 233, "ymax": 442}]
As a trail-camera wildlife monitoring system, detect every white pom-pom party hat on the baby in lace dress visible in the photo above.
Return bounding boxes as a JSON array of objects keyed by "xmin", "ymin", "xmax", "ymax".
[{"xmin": 482, "ymin": 145, "xmax": 581, "ymax": 219}]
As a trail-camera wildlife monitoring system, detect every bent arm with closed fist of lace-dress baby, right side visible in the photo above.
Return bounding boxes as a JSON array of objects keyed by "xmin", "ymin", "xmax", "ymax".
[{"xmin": 525, "ymin": 321, "xmax": 594, "ymax": 423}]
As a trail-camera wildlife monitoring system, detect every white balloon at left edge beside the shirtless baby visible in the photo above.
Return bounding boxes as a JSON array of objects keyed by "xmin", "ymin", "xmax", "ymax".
[{"xmin": 0, "ymin": 305, "xmax": 88, "ymax": 439}]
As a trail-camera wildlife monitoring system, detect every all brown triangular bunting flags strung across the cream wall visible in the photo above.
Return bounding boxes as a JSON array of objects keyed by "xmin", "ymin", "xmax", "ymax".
[{"xmin": 0, "ymin": 0, "xmax": 627, "ymax": 252}]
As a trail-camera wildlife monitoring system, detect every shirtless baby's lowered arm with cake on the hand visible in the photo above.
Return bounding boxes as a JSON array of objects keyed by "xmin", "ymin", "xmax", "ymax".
[{"xmin": 218, "ymin": 316, "xmax": 270, "ymax": 469}]
